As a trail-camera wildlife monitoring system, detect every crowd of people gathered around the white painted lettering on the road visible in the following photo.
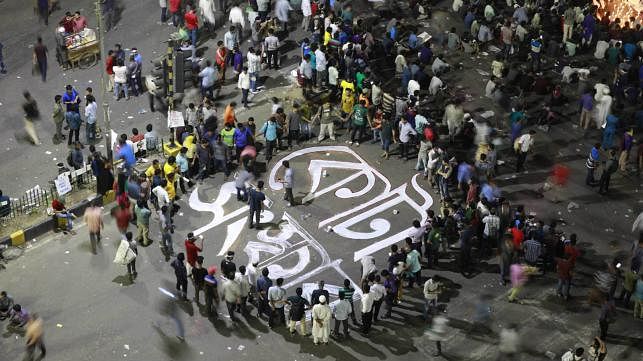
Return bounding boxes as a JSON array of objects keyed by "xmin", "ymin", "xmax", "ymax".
[{"xmin": 0, "ymin": 0, "xmax": 643, "ymax": 360}]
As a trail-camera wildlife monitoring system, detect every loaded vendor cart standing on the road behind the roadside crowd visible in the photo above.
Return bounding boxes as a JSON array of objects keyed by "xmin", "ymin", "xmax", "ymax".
[{"xmin": 56, "ymin": 28, "xmax": 100, "ymax": 69}]
